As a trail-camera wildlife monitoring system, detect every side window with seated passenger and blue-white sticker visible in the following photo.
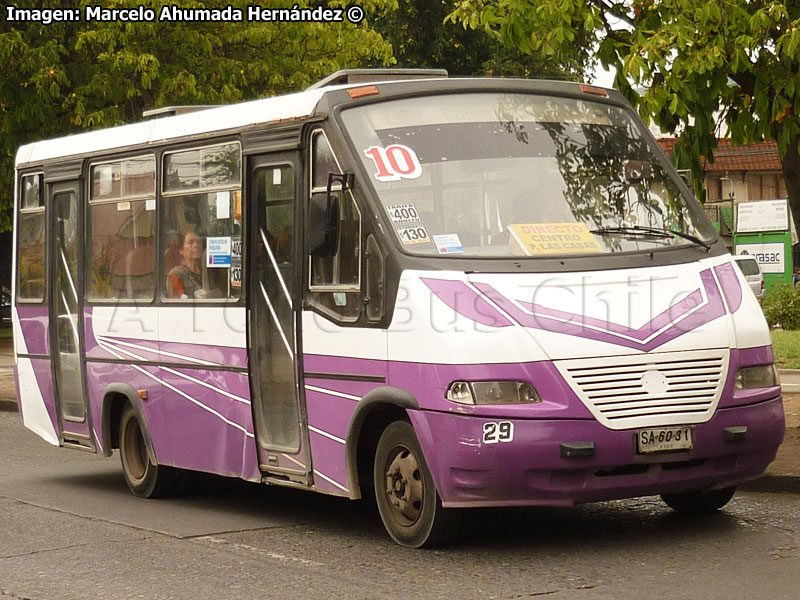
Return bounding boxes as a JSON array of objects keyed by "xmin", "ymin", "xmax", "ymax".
[{"xmin": 161, "ymin": 143, "xmax": 243, "ymax": 301}]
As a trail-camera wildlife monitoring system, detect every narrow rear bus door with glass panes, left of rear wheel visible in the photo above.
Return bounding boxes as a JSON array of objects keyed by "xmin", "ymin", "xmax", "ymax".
[{"xmin": 49, "ymin": 181, "xmax": 94, "ymax": 449}]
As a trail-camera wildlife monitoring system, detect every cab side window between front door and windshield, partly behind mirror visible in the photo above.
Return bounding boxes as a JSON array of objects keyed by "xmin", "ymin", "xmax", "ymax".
[{"xmin": 309, "ymin": 131, "xmax": 361, "ymax": 320}]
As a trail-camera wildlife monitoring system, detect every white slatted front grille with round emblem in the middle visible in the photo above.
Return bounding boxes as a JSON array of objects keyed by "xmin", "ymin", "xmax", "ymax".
[{"xmin": 556, "ymin": 348, "xmax": 729, "ymax": 429}]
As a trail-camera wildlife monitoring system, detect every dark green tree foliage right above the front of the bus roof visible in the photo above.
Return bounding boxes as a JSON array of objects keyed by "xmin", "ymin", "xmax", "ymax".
[{"xmin": 371, "ymin": 0, "xmax": 588, "ymax": 79}]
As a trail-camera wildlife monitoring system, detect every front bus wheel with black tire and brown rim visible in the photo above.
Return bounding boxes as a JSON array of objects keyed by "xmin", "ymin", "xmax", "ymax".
[{"xmin": 373, "ymin": 421, "xmax": 460, "ymax": 548}]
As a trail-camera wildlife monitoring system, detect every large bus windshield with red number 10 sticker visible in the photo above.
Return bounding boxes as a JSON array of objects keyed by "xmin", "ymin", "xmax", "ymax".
[{"xmin": 342, "ymin": 93, "xmax": 715, "ymax": 257}]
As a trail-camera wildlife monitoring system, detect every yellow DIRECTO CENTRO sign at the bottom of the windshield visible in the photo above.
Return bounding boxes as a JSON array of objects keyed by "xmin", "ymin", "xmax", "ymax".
[{"xmin": 508, "ymin": 223, "xmax": 603, "ymax": 256}]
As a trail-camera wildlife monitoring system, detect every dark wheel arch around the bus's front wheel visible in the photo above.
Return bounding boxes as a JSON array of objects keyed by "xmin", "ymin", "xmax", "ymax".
[{"xmin": 345, "ymin": 386, "xmax": 419, "ymax": 500}]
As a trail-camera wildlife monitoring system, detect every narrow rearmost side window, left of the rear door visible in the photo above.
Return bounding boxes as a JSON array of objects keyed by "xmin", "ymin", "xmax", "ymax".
[{"xmin": 17, "ymin": 173, "xmax": 46, "ymax": 302}]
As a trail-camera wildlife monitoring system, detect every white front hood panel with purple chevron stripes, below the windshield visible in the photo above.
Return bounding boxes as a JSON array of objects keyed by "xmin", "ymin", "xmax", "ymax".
[{"xmin": 388, "ymin": 256, "xmax": 771, "ymax": 364}]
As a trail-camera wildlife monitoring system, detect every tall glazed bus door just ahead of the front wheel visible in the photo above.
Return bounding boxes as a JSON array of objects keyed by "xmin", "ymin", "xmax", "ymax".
[{"xmin": 247, "ymin": 153, "xmax": 311, "ymax": 485}]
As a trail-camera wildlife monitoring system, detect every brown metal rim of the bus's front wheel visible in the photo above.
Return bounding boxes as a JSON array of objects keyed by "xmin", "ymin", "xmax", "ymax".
[{"xmin": 384, "ymin": 446, "xmax": 425, "ymax": 527}]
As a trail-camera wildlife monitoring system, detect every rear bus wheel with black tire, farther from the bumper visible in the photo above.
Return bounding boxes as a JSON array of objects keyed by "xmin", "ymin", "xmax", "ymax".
[{"xmin": 119, "ymin": 404, "xmax": 182, "ymax": 498}]
